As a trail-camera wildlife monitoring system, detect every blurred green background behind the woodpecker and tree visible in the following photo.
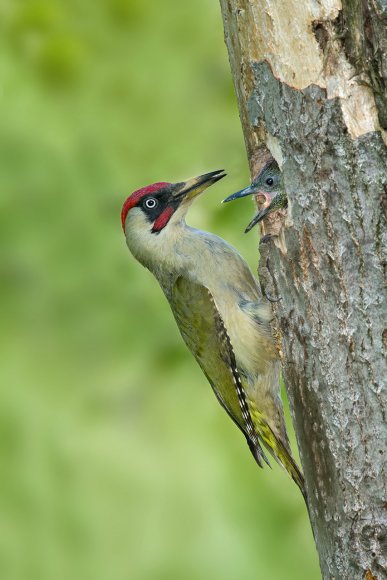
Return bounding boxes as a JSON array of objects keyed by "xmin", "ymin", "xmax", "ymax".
[{"xmin": 0, "ymin": 0, "xmax": 319, "ymax": 580}]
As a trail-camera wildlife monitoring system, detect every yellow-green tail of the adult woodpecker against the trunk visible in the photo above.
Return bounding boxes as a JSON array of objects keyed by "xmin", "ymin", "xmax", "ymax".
[{"xmin": 252, "ymin": 409, "xmax": 306, "ymax": 502}]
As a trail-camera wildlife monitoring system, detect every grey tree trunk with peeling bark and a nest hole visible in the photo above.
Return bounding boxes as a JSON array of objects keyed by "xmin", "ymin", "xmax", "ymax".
[{"xmin": 221, "ymin": 0, "xmax": 387, "ymax": 580}]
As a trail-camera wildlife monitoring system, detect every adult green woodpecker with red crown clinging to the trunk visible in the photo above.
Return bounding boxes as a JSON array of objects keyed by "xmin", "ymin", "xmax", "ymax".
[{"xmin": 121, "ymin": 171, "xmax": 305, "ymax": 496}]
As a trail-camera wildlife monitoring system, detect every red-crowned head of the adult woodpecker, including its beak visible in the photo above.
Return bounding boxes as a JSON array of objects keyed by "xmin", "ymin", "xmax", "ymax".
[{"xmin": 121, "ymin": 170, "xmax": 226, "ymax": 259}]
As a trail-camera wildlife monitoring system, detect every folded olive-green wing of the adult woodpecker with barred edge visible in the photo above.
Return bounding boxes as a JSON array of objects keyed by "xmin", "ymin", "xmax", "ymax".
[{"xmin": 170, "ymin": 276, "xmax": 268, "ymax": 466}]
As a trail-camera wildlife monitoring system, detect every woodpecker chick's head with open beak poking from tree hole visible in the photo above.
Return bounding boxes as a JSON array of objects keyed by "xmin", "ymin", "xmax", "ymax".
[{"xmin": 224, "ymin": 160, "xmax": 288, "ymax": 234}]
